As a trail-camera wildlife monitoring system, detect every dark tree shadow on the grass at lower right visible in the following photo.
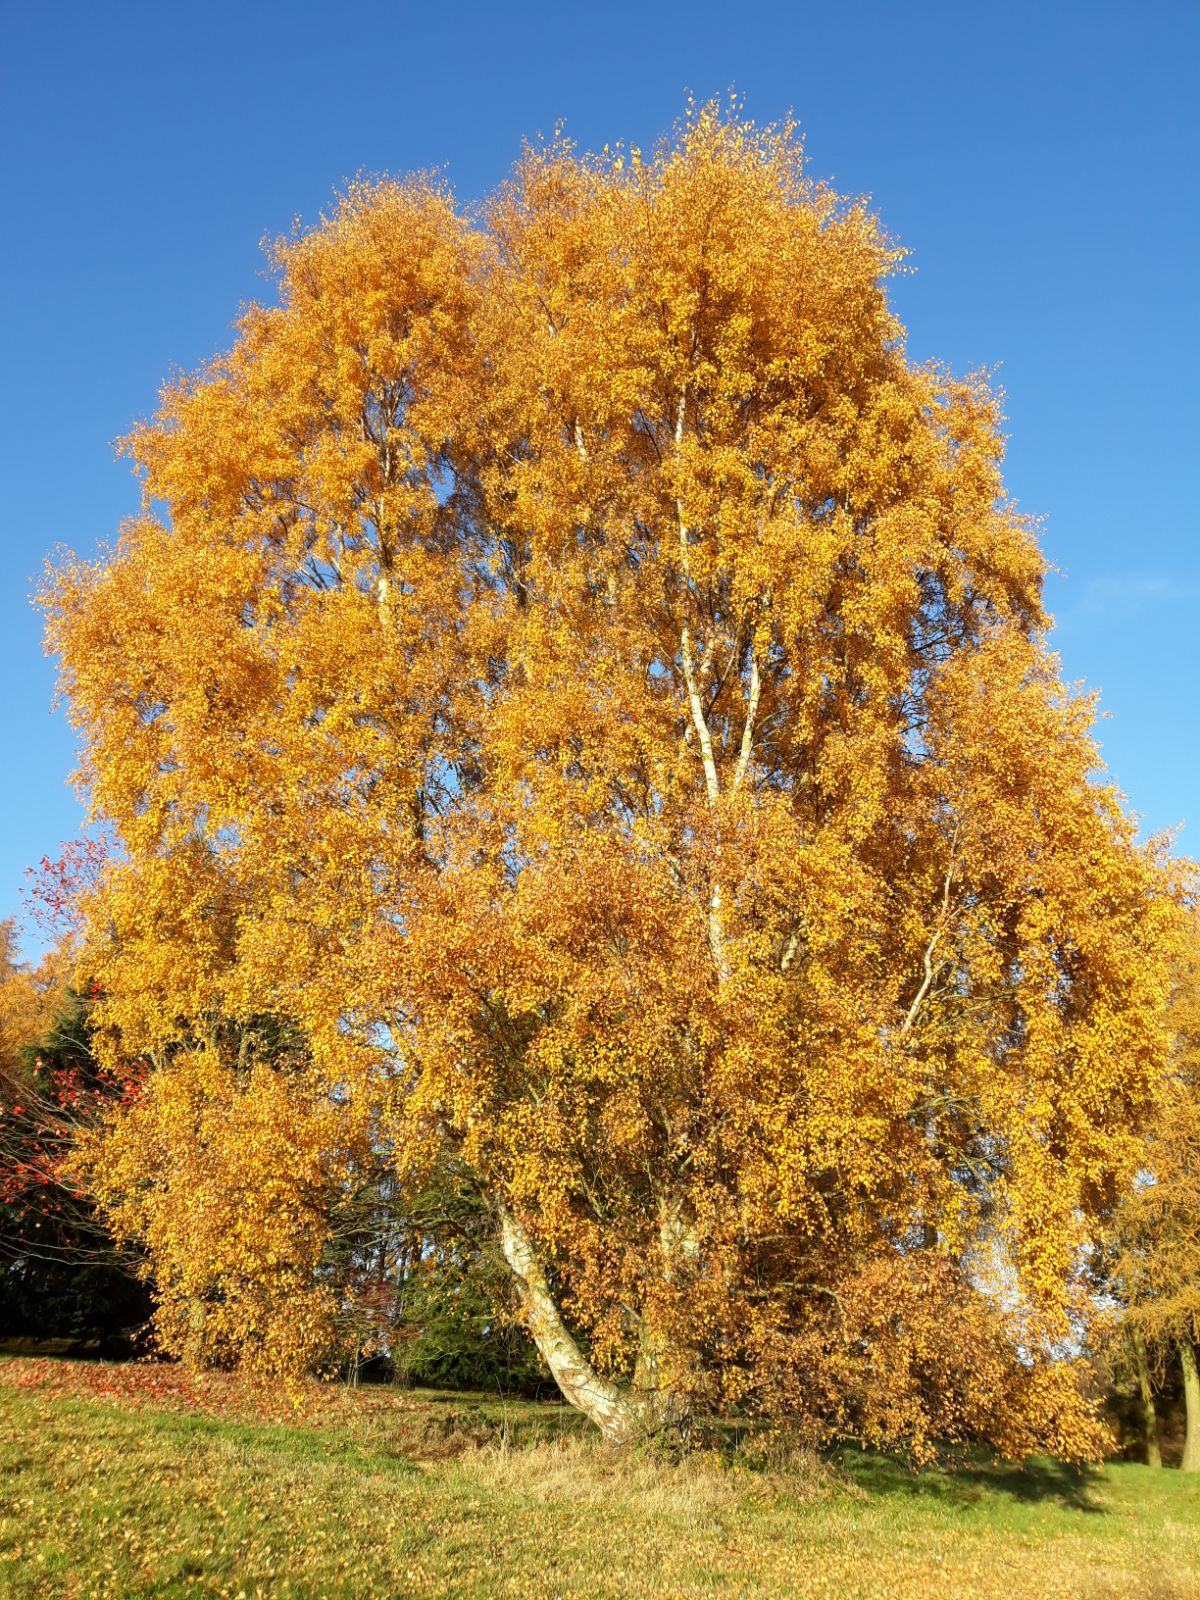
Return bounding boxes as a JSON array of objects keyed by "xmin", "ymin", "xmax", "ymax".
[{"xmin": 834, "ymin": 1446, "xmax": 1104, "ymax": 1517}]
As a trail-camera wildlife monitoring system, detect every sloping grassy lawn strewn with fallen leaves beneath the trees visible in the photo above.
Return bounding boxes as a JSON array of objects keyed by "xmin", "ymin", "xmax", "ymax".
[{"xmin": 0, "ymin": 1362, "xmax": 1200, "ymax": 1600}]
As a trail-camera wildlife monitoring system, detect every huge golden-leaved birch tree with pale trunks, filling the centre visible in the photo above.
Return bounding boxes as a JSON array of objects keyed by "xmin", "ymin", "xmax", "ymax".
[{"xmin": 43, "ymin": 107, "xmax": 1176, "ymax": 1453}]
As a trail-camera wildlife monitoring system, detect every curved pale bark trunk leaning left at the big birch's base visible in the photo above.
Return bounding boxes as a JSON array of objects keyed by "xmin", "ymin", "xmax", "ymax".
[{"xmin": 498, "ymin": 1205, "xmax": 662, "ymax": 1445}]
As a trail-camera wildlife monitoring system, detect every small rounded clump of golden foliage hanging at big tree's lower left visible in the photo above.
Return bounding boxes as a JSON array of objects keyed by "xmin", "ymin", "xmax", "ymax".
[{"xmin": 80, "ymin": 1042, "xmax": 369, "ymax": 1382}]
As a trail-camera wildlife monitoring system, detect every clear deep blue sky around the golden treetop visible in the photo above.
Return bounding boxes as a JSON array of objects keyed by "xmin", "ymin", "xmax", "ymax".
[{"xmin": 0, "ymin": 0, "xmax": 1200, "ymax": 952}]
